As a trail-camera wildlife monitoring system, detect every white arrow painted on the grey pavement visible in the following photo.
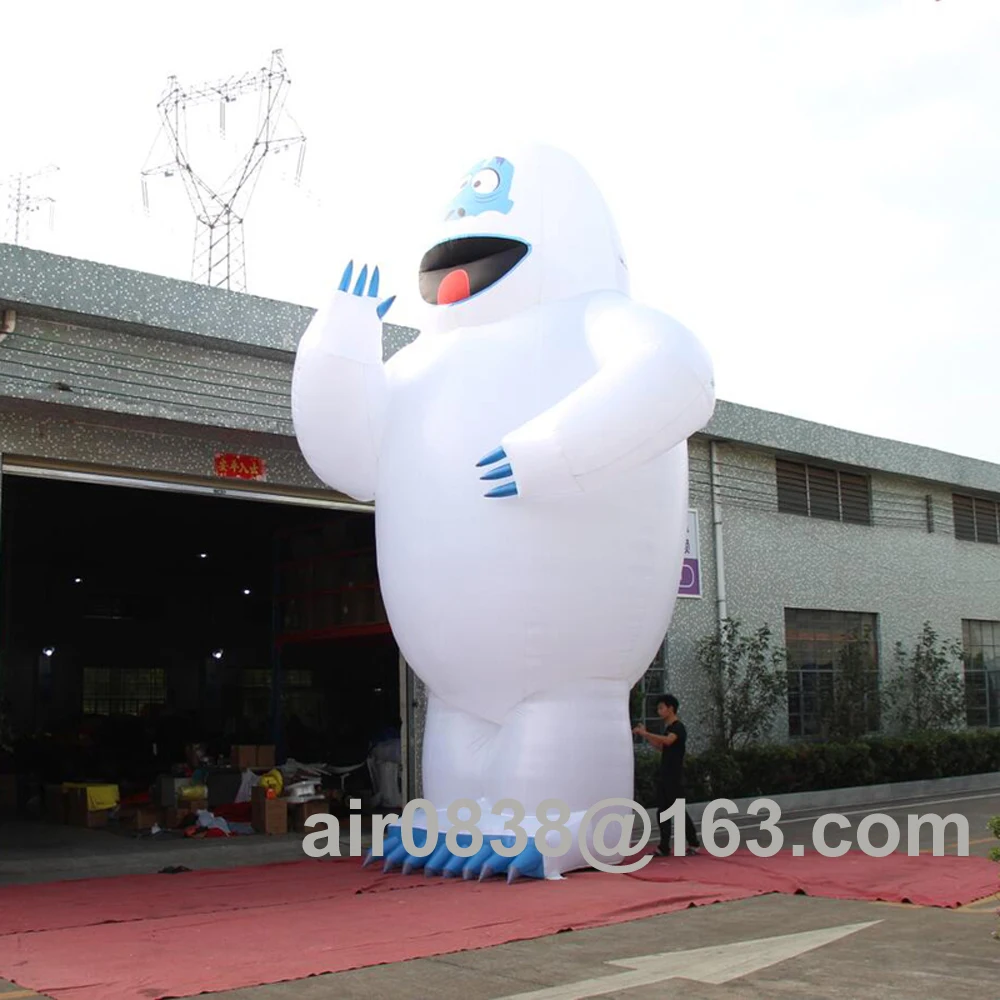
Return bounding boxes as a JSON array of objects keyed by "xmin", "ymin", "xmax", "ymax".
[{"xmin": 499, "ymin": 920, "xmax": 882, "ymax": 1000}]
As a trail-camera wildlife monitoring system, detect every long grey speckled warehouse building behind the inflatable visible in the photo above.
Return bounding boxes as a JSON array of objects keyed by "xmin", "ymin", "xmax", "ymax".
[{"xmin": 0, "ymin": 236, "xmax": 1000, "ymax": 797}]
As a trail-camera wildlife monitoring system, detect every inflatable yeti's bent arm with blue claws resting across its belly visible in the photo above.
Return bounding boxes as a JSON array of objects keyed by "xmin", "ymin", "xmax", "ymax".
[{"xmin": 480, "ymin": 294, "xmax": 715, "ymax": 497}]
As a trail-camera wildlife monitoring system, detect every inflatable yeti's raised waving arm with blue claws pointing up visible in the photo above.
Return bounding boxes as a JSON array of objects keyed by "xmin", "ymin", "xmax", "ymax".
[{"xmin": 292, "ymin": 264, "xmax": 393, "ymax": 501}]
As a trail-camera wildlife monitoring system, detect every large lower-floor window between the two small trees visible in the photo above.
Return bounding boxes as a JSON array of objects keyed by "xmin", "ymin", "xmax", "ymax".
[{"xmin": 785, "ymin": 608, "xmax": 880, "ymax": 738}]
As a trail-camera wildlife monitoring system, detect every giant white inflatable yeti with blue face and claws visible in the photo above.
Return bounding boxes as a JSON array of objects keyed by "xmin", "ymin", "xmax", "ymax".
[{"xmin": 292, "ymin": 147, "xmax": 715, "ymax": 877}]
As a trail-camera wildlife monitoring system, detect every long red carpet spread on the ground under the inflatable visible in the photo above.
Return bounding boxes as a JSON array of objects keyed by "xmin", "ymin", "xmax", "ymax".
[{"xmin": 0, "ymin": 851, "xmax": 997, "ymax": 1000}]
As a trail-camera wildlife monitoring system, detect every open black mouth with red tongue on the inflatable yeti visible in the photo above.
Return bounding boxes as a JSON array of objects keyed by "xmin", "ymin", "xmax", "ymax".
[{"xmin": 420, "ymin": 236, "xmax": 528, "ymax": 306}]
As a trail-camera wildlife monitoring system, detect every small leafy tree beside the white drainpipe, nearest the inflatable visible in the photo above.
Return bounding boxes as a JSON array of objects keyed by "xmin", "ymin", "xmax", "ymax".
[{"xmin": 697, "ymin": 618, "xmax": 788, "ymax": 752}]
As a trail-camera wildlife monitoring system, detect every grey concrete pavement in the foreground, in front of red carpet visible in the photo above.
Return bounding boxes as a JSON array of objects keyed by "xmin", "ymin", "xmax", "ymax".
[{"xmin": 180, "ymin": 896, "xmax": 1000, "ymax": 1000}]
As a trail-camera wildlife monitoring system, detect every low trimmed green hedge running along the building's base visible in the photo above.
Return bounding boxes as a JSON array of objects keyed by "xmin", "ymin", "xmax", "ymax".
[{"xmin": 635, "ymin": 729, "xmax": 1000, "ymax": 806}]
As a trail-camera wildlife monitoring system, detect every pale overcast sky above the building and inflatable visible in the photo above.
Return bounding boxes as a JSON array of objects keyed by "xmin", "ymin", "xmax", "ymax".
[{"xmin": 0, "ymin": 0, "xmax": 1000, "ymax": 462}]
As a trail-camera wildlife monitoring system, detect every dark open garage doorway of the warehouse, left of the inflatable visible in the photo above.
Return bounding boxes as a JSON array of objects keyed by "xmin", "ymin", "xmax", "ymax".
[{"xmin": 0, "ymin": 457, "xmax": 408, "ymax": 844}]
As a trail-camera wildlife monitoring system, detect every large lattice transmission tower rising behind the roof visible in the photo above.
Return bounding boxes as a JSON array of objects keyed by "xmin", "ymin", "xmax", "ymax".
[{"xmin": 142, "ymin": 49, "xmax": 306, "ymax": 292}]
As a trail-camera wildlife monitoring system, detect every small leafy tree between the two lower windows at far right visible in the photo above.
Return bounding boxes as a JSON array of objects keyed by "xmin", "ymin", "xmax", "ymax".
[{"xmin": 887, "ymin": 622, "xmax": 966, "ymax": 732}]
